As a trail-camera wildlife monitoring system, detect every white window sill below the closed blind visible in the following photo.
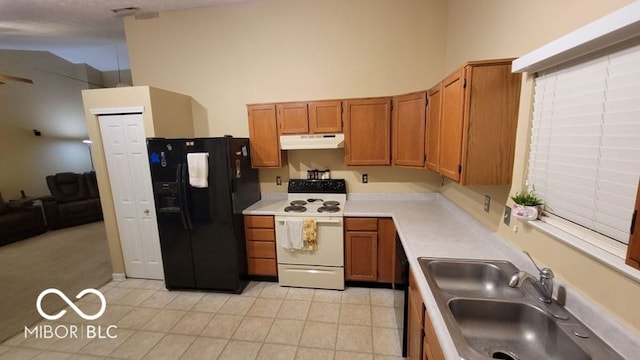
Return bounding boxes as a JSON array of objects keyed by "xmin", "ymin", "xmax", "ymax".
[{"xmin": 527, "ymin": 220, "xmax": 640, "ymax": 281}]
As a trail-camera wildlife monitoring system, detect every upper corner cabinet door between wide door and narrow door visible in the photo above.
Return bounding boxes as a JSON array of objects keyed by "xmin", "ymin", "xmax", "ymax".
[{"xmin": 391, "ymin": 92, "xmax": 427, "ymax": 168}]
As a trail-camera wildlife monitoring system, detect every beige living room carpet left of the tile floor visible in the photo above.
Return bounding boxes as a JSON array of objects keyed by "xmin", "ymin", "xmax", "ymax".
[{"xmin": 0, "ymin": 221, "xmax": 112, "ymax": 343}]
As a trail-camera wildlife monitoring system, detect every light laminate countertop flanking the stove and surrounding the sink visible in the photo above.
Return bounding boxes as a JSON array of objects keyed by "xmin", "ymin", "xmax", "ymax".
[{"xmin": 243, "ymin": 193, "xmax": 640, "ymax": 359}]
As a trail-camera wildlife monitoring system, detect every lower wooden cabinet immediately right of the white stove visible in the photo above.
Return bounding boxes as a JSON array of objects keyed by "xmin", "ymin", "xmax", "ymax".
[{"xmin": 344, "ymin": 217, "xmax": 396, "ymax": 283}]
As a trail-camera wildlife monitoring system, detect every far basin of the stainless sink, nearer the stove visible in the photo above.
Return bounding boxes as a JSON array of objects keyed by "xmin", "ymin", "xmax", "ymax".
[{"xmin": 427, "ymin": 260, "xmax": 524, "ymax": 298}]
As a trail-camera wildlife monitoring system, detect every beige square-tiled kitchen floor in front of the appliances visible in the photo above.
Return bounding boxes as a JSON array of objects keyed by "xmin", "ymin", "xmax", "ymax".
[{"xmin": 0, "ymin": 279, "xmax": 402, "ymax": 360}]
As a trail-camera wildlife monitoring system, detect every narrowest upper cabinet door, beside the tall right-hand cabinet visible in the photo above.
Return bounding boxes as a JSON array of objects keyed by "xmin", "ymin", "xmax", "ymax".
[{"xmin": 425, "ymin": 83, "xmax": 442, "ymax": 172}]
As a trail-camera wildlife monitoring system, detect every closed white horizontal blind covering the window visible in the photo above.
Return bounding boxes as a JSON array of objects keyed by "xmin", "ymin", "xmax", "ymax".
[{"xmin": 528, "ymin": 45, "xmax": 640, "ymax": 244}]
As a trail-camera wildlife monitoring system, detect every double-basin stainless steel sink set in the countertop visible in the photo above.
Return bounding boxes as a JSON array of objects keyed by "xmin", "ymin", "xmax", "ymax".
[{"xmin": 418, "ymin": 258, "xmax": 622, "ymax": 360}]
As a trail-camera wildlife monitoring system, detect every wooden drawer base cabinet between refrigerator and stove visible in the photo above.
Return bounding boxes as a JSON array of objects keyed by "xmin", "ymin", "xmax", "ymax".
[{"xmin": 244, "ymin": 215, "xmax": 278, "ymax": 276}]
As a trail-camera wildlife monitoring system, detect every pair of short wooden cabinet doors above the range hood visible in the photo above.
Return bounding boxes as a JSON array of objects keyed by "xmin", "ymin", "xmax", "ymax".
[{"xmin": 276, "ymin": 100, "xmax": 342, "ymax": 135}]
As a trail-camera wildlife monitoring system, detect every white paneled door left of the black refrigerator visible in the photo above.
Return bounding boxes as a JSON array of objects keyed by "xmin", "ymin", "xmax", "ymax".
[{"xmin": 98, "ymin": 114, "xmax": 164, "ymax": 280}]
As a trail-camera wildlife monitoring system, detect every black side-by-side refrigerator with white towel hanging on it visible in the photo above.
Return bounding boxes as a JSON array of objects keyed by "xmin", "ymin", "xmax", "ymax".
[{"xmin": 147, "ymin": 136, "xmax": 260, "ymax": 293}]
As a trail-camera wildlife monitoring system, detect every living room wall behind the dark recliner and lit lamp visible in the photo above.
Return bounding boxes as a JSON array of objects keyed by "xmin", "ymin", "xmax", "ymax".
[{"xmin": 0, "ymin": 50, "xmax": 91, "ymax": 199}]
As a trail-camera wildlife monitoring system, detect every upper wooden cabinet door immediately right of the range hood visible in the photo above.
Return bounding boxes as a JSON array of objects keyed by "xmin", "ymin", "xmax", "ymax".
[{"xmin": 343, "ymin": 98, "xmax": 391, "ymax": 165}]
